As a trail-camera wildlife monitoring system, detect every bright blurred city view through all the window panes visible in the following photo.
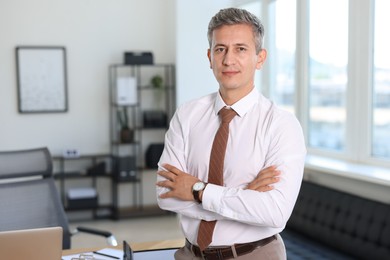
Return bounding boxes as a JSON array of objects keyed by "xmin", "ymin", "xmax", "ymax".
[{"xmin": 243, "ymin": 0, "xmax": 390, "ymax": 160}]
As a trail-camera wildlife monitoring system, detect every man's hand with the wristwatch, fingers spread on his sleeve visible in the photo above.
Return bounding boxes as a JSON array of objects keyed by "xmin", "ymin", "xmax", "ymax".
[{"xmin": 156, "ymin": 164, "xmax": 200, "ymax": 201}]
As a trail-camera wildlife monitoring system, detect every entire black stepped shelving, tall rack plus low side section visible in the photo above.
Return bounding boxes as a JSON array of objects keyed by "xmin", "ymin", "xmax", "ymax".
[{"xmin": 53, "ymin": 64, "xmax": 176, "ymax": 219}]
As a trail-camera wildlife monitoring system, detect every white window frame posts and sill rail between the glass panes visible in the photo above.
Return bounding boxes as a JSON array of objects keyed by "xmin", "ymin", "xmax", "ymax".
[{"xmin": 235, "ymin": 0, "xmax": 390, "ymax": 167}]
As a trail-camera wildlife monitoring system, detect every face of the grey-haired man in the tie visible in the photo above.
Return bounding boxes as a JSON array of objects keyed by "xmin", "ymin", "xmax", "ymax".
[{"xmin": 207, "ymin": 24, "xmax": 266, "ymax": 95}]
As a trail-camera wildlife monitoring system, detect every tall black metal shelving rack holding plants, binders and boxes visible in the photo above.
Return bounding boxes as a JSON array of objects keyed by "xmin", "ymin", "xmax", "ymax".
[{"xmin": 109, "ymin": 64, "xmax": 176, "ymax": 218}]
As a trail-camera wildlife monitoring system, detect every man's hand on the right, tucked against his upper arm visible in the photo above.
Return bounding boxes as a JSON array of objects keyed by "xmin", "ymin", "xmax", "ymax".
[{"xmin": 246, "ymin": 166, "xmax": 280, "ymax": 192}]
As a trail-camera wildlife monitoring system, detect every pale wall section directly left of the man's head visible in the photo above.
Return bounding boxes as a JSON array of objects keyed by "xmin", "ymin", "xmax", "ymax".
[{"xmin": 176, "ymin": 0, "xmax": 232, "ymax": 105}]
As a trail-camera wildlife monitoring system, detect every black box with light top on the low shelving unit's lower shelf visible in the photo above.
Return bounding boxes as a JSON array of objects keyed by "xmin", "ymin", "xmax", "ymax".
[{"xmin": 66, "ymin": 187, "xmax": 98, "ymax": 209}]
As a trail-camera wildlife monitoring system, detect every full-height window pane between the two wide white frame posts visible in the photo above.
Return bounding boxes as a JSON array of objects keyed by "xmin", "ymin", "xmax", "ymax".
[{"xmin": 307, "ymin": 0, "xmax": 348, "ymax": 151}]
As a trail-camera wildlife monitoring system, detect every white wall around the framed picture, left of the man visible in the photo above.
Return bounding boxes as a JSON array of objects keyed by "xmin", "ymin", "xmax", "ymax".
[{"xmin": 0, "ymin": 0, "xmax": 176, "ymax": 154}]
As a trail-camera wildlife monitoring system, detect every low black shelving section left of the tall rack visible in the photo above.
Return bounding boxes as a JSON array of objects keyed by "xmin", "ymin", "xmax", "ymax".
[{"xmin": 53, "ymin": 154, "xmax": 112, "ymax": 218}]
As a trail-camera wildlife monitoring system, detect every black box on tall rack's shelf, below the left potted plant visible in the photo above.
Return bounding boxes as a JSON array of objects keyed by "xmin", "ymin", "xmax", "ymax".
[{"xmin": 112, "ymin": 156, "xmax": 137, "ymax": 181}]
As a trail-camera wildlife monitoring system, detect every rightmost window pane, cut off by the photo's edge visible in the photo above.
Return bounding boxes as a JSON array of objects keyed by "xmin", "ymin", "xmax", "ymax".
[{"xmin": 371, "ymin": 0, "xmax": 390, "ymax": 159}]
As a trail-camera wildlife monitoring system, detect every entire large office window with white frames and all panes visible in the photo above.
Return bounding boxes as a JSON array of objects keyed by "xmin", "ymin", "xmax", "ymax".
[{"xmin": 232, "ymin": 0, "xmax": 390, "ymax": 166}]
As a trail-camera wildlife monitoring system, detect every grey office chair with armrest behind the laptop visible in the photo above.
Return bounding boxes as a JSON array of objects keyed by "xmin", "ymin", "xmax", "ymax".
[{"xmin": 0, "ymin": 147, "xmax": 117, "ymax": 249}]
